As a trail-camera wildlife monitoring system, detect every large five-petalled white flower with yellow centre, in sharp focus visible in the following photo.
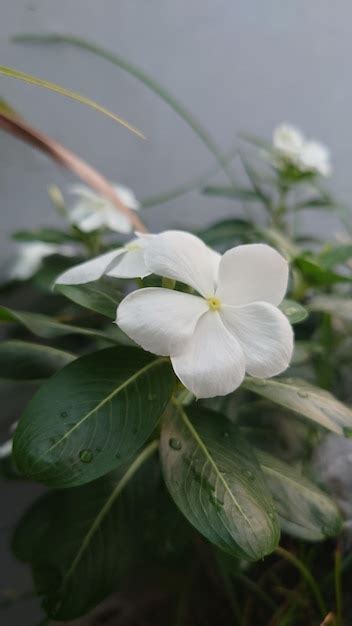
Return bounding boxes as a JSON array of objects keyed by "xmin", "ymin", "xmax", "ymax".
[{"xmin": 116, "ymin": 231, "xmax": 293, "ymax": 398}]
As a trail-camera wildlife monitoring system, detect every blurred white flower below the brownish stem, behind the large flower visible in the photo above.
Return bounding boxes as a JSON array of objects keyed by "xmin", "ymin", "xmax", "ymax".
[{"xmin": 69, "ymin": 185, "xmax": 140, "ymax": 233}]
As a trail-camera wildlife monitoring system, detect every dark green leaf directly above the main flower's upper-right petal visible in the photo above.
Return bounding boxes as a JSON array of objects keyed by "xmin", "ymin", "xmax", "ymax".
[{"xmin": 196, "ymin": 218, "xmax": 257, "ymax": 249}]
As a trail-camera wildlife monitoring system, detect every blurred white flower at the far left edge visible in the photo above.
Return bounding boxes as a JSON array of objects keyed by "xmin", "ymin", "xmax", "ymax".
[{"xmin": 3, "ymin": 241, "xmax": 75, "ymax": 280}]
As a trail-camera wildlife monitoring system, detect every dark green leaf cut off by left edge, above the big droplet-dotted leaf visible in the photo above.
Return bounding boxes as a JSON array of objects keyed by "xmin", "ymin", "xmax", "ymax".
[{"xmin": 0, "ymin": 340, "xmax": 76, "ymax": 380}]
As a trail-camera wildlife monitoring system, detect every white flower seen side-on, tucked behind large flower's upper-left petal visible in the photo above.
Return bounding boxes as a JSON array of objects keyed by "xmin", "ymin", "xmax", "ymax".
[{"xmin": 55, "ymin": 238, "xmax": 150, "ymax": 285}]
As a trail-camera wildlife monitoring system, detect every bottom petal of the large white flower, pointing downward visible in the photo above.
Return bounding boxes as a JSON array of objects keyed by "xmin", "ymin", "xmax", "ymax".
[{"xmin": 171, "ymin": 310, "xmax": 245, "ymax": 398}]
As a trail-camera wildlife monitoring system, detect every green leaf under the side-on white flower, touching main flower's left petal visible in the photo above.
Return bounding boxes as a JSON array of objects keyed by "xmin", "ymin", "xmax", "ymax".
[{"xmin": 55, "ymin": 276, "xmax": 122, "ymax": 320}]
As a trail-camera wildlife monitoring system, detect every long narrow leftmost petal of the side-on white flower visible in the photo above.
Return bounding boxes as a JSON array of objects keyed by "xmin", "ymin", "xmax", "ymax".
[{"xmin": 55, "ymin": 248, "xmax": 125, "ymax": 285}]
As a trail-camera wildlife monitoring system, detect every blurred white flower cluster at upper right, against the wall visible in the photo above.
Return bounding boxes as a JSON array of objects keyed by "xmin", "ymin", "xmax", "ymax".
[{"xmin": 273, "ymin": 124, "xmax": 332, "ymax": 176}]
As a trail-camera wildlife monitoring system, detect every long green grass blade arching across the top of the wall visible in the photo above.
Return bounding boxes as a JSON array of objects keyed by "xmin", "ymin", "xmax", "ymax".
[{"xmin": 12, "ymin": 33, "xmax": 233, "ymax": 182}]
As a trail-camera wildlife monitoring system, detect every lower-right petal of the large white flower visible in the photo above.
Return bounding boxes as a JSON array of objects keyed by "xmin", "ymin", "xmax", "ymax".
[{"xmin": 220, "ymin": 302, "xmax": 293, "ymax": 378}]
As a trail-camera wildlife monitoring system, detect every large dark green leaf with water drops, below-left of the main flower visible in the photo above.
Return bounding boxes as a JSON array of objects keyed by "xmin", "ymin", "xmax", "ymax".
[{"xmin": 14, "ymin": 346, "xmax": 175, "ymax": 487}]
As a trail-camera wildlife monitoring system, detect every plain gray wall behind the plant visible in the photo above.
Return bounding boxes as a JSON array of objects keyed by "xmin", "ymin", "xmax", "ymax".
[{"xmin": 0, "ymin": 0, "xmax": 352, "ymax": 254}]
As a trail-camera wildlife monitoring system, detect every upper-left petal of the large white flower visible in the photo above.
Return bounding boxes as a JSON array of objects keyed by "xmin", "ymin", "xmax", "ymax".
[{"xmin": 140, "ymin": 230, "xmax": 221, "ymax": 298}]
